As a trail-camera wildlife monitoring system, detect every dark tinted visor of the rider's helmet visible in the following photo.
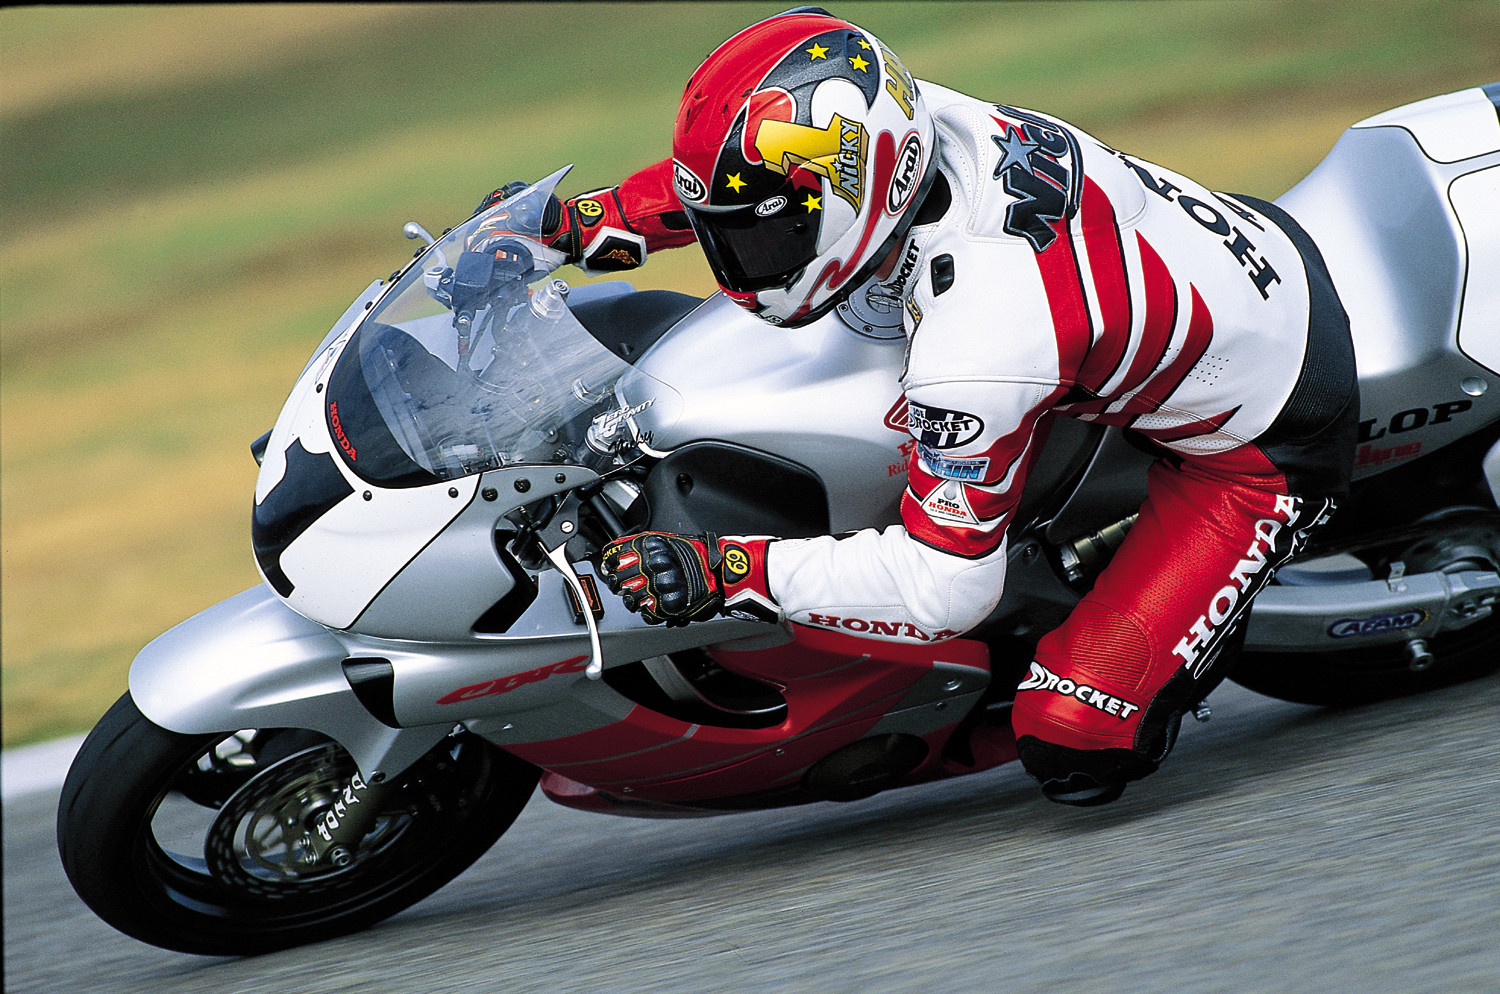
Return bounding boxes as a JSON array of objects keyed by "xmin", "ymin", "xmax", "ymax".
[{"xmin": 684, "ymin": 201, "xmax": 822, "ymax": 292}]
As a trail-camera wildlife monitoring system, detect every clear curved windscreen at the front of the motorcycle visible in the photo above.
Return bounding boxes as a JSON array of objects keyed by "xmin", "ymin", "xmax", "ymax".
[{"xmin": 326, "ymin": 175, "xmax": 672, "ymax": 486}]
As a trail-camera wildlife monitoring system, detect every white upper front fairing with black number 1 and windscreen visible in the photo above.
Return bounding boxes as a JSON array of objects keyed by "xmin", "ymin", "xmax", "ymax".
[{"xmin": 254, "ymin": 174, "xmax": 671, "ymax": 631}]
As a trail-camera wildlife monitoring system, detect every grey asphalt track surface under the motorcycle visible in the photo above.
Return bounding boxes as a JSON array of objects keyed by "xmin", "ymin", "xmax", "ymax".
[{"xmin": 5, "ymin": 678, "xmax": 1500, "ymax": 994}]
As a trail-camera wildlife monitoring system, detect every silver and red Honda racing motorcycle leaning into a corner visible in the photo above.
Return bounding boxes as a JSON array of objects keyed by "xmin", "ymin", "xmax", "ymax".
[{"xmin": 57, "ymin": 84, "xmax": 1500, "ymax": 955}]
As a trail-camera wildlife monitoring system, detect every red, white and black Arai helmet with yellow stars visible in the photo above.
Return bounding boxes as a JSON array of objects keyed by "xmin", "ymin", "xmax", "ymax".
[{"xmin": 672, "ymin": 7, "xmax": 935, "ymax": 327}]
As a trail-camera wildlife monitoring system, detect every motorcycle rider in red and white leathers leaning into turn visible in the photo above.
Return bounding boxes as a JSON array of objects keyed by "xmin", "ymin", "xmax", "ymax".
[{"xmin": 483, "ymin": 7, "xmax": 1358, "ymax": 804}]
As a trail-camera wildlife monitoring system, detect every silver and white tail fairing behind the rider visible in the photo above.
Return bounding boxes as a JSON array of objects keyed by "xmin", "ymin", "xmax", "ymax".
[{"xmin": 1277, "ymin": 88, "xmax": 1500, "ymax": 480}]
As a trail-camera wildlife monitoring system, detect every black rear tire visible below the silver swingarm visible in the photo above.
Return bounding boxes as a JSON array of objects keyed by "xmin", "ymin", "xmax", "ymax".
[{"xmin": 1230, "ymin": 618, "xmax": 1500, "ymax": 706}]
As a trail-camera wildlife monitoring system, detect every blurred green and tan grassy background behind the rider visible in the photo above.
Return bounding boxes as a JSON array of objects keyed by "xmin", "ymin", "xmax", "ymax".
[{"xmin": 0, "ymin": 0, "xmax": 1500, "ymax": 745}]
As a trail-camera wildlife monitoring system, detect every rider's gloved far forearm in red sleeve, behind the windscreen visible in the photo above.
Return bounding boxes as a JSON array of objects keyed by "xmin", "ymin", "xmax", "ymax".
[{"xmin": 476, "ymin": 159, "xmax": 695, "ymax": 276}]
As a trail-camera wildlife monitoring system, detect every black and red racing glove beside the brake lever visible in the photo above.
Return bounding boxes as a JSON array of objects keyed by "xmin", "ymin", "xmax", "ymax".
[{"xmin": 600, "ymin": 532, "xmax": 782, "ymax": 627}]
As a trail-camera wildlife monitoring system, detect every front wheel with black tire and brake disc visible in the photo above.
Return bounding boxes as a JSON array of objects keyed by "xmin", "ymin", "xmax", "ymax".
[{"xmin": 57, "ymin": 694, "xmax": 539, "ymax": 955}]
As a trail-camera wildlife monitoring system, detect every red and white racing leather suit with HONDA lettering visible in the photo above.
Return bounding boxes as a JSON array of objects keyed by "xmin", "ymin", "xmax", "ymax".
[{"xmin": 570, "ymin": 82, "xmax": 1358, "ymax": 804}]
